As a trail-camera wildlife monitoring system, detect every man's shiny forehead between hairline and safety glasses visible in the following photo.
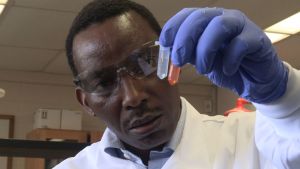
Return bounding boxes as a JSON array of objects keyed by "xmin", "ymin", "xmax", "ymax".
[{"xmin": 73, "ymin": 10, "xmax": 157, "ymax": 72}]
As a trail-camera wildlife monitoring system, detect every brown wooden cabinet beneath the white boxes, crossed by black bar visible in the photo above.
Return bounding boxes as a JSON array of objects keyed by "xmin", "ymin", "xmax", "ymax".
[{"xmin": 26, "ymin": 129, "xmax": 89, "ymax": 169}]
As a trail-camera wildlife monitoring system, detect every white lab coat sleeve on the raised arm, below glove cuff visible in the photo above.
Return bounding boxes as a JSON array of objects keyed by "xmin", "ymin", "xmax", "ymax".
[{"xmin": 254, "ymin": 63, "xmax": 300, "ymax": 169}]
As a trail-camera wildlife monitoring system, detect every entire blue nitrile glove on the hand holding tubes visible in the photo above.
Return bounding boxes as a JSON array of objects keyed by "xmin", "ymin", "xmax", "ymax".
[{"xmin": 159, "ymin": 8, "xmax": 288, "ymax": 103}]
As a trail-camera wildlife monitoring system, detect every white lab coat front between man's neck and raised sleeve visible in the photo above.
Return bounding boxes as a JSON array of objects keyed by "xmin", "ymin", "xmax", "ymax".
[{"xmin": 163, "ymin": 97, "xmax": 259, "ymax": 169}]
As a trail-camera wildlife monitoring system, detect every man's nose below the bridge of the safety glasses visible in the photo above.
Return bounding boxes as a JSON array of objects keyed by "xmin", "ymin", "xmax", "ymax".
[{"xmin": 120, "ymin": 75, "xmax": 149, "ymax": 110}]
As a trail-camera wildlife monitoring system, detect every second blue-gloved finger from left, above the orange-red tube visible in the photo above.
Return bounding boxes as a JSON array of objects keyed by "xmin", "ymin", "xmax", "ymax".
[{"xmin": 171, "ymin": 8, "xmax": 222, "ymax": 66}]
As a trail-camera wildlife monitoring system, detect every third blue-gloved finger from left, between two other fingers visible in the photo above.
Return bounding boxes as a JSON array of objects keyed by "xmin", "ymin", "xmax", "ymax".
[{"xmin": 196, "ymin": 10, "xmax": 244, "ymax": 74}]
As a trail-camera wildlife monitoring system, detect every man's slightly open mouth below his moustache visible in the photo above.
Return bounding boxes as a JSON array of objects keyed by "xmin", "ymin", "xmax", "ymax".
[{"xmin": 129, "ymin": 115, "xmax": 162, "ymax": 135}]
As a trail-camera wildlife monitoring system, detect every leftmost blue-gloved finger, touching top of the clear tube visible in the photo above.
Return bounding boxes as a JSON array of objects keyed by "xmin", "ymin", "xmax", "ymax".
[{"xmin": 159, "ymin": 8, "xmax": 197, "ymax": 47}]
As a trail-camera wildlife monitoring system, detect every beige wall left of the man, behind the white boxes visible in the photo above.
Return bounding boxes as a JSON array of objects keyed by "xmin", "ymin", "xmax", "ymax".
[{"xmin": 0, "ymin": 71, "xmax": 104, "ymax": 169}]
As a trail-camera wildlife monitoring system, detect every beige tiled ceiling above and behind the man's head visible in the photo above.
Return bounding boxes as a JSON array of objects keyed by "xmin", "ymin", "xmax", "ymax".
[{"xmin": 0, "ymin": 0, "xmax": 300, "ymax": 84}]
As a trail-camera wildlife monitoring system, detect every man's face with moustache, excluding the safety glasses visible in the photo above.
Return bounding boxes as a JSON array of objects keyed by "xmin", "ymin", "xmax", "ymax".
[{"xmin": 73, "ymin": 11, "xmax": 180, "ymax": 150}]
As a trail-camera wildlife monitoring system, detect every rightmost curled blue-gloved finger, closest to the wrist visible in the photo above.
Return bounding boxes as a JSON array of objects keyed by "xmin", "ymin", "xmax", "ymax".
[{"xmin": 223, "ymin": 20, "xmax": 267, "ymax": 76}]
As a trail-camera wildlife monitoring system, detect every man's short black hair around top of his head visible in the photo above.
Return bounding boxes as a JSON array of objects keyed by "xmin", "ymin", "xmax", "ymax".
[{"xmin": 66, "ymin": 0, "xmax": 161, "ymax": 77}]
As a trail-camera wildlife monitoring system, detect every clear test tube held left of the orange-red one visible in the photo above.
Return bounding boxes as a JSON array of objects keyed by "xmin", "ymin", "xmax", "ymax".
[{"xmin": 156, "ymin": 42, "xmax": 171, "ymax": 79}]
